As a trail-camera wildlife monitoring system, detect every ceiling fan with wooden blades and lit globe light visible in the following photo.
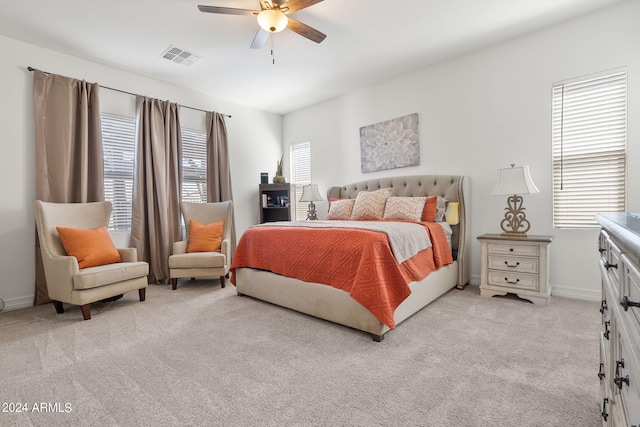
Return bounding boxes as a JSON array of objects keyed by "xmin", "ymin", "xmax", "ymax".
[{"xmin": 198, "ymin": 0, "xmax": 327, "ymax": 49}]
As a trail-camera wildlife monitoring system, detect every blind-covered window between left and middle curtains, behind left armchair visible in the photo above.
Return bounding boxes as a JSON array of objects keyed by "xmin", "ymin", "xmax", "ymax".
[{"xmin": 101, "ymin": 114, "xmax": 135, "ymax": 230}]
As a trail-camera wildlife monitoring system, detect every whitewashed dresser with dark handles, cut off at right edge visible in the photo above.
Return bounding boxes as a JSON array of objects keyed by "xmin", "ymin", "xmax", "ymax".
[{"xmin": 597, "ymin": 214, "xmax": 640, "ymax": 427}]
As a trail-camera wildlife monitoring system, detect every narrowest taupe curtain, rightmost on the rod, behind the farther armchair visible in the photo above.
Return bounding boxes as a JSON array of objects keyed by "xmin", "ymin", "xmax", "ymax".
[{"xmin": 206, "ymin": 111, "xmax": 236, "ymax": 254}]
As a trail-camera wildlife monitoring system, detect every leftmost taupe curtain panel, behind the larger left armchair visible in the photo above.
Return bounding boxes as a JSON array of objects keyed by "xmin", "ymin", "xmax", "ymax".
[{"xmin": 33, "ymin": 70, "xmax": 104, "ymax": 304}]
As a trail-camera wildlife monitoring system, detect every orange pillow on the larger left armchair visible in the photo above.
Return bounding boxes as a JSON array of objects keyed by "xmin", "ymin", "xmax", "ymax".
[{"xmin": 56, "ymin": 226, "xmax": 120, "ymax": 269}]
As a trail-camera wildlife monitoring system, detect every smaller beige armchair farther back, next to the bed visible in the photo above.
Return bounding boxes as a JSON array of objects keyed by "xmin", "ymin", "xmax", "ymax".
[{"xmin": 169, "ymin": 201, "xmax": 234, "ymax": 290}]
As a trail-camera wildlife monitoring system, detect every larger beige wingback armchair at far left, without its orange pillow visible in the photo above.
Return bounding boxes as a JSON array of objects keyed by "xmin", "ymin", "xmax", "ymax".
[{"xmin": 34, "ymin": 200, "xmax": 149, "ymax": 320}]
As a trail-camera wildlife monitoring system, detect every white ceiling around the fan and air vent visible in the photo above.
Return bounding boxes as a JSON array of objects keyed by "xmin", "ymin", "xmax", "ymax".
[{"xmin": 0, "ymin": 0, "xmax": 621, "ymax": 114}]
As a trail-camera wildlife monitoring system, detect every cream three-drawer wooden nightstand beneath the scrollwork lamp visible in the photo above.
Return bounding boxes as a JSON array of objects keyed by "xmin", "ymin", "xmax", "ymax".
[{"xmin": 478, "ymin": 234, "xmax": 553, "ymax": 305}]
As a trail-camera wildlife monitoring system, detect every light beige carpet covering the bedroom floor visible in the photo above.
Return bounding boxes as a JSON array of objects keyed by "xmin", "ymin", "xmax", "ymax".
[{"xmin": 0, "ymin": 280, "xmax": 602, "ymax": 427}]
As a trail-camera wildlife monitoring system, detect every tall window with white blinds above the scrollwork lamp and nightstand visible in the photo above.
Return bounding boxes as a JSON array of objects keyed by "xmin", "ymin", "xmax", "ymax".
[{"xmin": 552, "ymin": 70, "xmax": 627, "ymax": 228}]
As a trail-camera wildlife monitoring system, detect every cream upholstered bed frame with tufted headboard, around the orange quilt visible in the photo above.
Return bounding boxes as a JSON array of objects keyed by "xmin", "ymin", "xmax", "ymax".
[{"xmin": 231, "ymin": 175, "xmax": 471, "ymax": 341}]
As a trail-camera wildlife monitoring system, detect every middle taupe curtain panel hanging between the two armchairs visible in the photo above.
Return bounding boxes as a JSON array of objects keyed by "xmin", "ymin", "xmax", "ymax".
[{"xmin": 131, "ymin": 95, "xmax": 182, "ymax": 284}]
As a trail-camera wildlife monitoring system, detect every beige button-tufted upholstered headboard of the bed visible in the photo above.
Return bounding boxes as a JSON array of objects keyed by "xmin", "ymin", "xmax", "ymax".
[{"xmin": 327, "ymin": 175, "xmax": 471, "ymax": 287}]
